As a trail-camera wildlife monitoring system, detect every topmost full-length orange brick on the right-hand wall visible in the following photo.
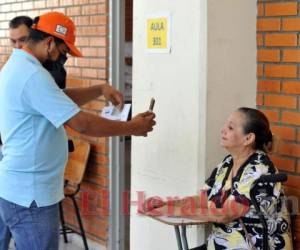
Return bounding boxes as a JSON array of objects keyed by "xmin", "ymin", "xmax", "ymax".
[{"xmin": 265, "ymin": 2, "xmax": 298, "ymax": 16}]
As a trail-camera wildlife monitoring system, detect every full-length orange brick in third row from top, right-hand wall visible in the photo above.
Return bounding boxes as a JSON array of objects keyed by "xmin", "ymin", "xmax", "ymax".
[{"xmin": 265, "ymin": 33, "xmax": 297, "ymax": 46}]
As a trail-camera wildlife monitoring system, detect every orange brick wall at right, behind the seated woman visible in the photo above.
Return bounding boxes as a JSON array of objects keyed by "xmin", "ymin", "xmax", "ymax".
[{"xmin": 257, "ymin": 0, "xmax": 300, "ymax": 187}]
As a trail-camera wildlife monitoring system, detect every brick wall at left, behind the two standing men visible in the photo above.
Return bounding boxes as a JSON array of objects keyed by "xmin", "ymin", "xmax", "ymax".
[{"xmin": 0, "ymin": 0, "xmax": 108, "ymax": 244}]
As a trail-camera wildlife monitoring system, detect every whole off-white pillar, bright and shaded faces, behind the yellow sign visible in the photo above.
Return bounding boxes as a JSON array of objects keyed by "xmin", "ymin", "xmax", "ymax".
[{"xmin": 130, "ymin": 0, "xmax": 256, "ymax": 250}]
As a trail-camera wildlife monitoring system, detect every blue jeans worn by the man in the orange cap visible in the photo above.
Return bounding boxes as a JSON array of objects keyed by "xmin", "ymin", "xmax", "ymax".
[{"xmin": 0, "ymin": 198, "xmax": 59, "ymax": 250}]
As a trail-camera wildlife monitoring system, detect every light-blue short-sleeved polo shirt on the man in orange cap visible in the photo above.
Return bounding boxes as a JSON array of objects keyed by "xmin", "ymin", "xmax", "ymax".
[{"xmin": 0, "ymin": 49, "xmax": 80, "ymax": 207}]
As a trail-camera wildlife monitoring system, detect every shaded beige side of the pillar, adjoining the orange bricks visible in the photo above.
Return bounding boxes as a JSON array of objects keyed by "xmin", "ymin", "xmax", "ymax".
[{"xmin": 206, "ymin": 0, "xmax": 256, "ymax": 178}]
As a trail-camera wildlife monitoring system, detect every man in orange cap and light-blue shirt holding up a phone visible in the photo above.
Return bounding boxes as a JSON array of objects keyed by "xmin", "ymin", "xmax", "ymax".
[{"xmin": 0, "ymin": 12, "xmax": 155, "ymax": 250}]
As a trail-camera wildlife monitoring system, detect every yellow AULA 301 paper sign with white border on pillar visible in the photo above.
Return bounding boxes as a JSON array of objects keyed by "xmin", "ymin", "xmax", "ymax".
[{"xmin": 146, "ymin": 14, "xmax": 171, "ymax": 53}]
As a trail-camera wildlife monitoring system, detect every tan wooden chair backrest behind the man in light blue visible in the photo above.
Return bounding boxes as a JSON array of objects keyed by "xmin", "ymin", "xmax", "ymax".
[{"xmin": 64, "ymin": 139, "xmax": 91, "ymax": 185}]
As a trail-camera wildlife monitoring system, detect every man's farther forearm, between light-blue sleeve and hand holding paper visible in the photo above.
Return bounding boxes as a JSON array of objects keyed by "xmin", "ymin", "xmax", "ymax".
[{"xmin": 64, "ymin": 85, "xmax": 103, "ymax": 106}]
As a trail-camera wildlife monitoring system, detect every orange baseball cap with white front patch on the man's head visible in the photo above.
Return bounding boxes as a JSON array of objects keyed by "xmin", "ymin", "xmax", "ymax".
[{"xmin": 31, "ymin": 12, "xmax": 82, "ymax": 57}]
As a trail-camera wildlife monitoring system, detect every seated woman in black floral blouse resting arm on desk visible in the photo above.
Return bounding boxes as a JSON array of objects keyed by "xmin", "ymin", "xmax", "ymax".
[{"xmin": 143, "ymin": 107, "xmax": 292, "ymax": 250}]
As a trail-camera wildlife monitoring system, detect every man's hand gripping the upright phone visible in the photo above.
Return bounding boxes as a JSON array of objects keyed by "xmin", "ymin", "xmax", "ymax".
[{"xmin": 129, "ymin": 111, "xmax": 156, "ymax": 136}]
